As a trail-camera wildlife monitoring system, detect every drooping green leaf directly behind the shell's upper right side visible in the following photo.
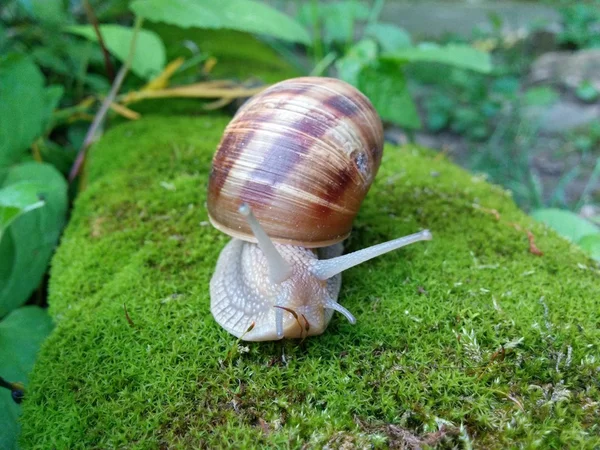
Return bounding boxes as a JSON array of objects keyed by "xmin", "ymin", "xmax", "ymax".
[{"xmin": 358, "ymin": 61, "xmax": 421, "ymax": 129}]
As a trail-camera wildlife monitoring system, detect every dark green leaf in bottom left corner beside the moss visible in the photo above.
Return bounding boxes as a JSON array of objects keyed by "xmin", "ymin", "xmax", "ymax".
[{"xmin": 0, "ymin": 306, "xmax": 52, "ymax": 450}]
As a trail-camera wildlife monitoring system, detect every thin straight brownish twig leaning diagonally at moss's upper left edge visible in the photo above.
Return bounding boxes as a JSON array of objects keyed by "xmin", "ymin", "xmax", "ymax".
[{"xmin": 69, "ymin": 17, "xmax": 143, "ymax": 182}]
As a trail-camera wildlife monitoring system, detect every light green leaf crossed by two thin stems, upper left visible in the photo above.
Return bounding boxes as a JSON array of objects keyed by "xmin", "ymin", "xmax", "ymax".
[{"xmin": 66, "ymin": 25, "xmax": 166, "ymax": 79}]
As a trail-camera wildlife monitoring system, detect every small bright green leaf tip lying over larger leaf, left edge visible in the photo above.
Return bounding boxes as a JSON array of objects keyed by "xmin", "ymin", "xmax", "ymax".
[{"xmin": 0, "ymin": 181, "xmax": 44, "ymax": 241}]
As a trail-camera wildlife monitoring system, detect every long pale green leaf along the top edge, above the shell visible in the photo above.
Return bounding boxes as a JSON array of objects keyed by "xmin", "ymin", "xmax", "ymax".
[{"xmin": 131, "ymin": 0, "xmax": 310, "ymax": 44}]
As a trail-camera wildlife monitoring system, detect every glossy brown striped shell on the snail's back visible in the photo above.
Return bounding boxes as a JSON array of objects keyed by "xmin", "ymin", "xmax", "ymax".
[{"xmin": 208, "ymin": 77, "xmax": 383, "ymax": 247}]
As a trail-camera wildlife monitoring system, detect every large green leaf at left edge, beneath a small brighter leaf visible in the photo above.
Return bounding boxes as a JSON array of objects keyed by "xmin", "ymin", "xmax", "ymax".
[{"xmin": 0, "ymin": 162, "xmax": 67, "ymax": 317}]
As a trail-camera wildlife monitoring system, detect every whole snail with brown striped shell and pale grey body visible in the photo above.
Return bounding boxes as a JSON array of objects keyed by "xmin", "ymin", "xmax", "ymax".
[{"xmin": 207, "ymin": 77, "xmax": 431, "ymax": 341}]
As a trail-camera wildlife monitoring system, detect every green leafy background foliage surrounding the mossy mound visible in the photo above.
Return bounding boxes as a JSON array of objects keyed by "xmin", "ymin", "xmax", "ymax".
[{"xmin": 0, "ymin": 0, "xmax": 600, "ymax": 448}]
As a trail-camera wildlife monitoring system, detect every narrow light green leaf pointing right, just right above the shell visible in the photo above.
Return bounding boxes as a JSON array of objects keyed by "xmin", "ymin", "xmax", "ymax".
[{"xmin": 382, "ymin": 43, "xmax": 492, "ymax": 73}]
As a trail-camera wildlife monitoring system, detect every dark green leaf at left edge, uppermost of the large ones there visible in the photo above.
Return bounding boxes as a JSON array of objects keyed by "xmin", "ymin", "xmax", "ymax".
[{"xmin": 0, "ymin": 55, "xmax": 46, "ymax": 168}]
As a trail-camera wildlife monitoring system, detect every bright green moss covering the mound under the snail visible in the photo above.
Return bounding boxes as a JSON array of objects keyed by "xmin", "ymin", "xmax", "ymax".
[{"xmin": 22, "ymin": 117, "xmax": 600, "ymax": 449}]
